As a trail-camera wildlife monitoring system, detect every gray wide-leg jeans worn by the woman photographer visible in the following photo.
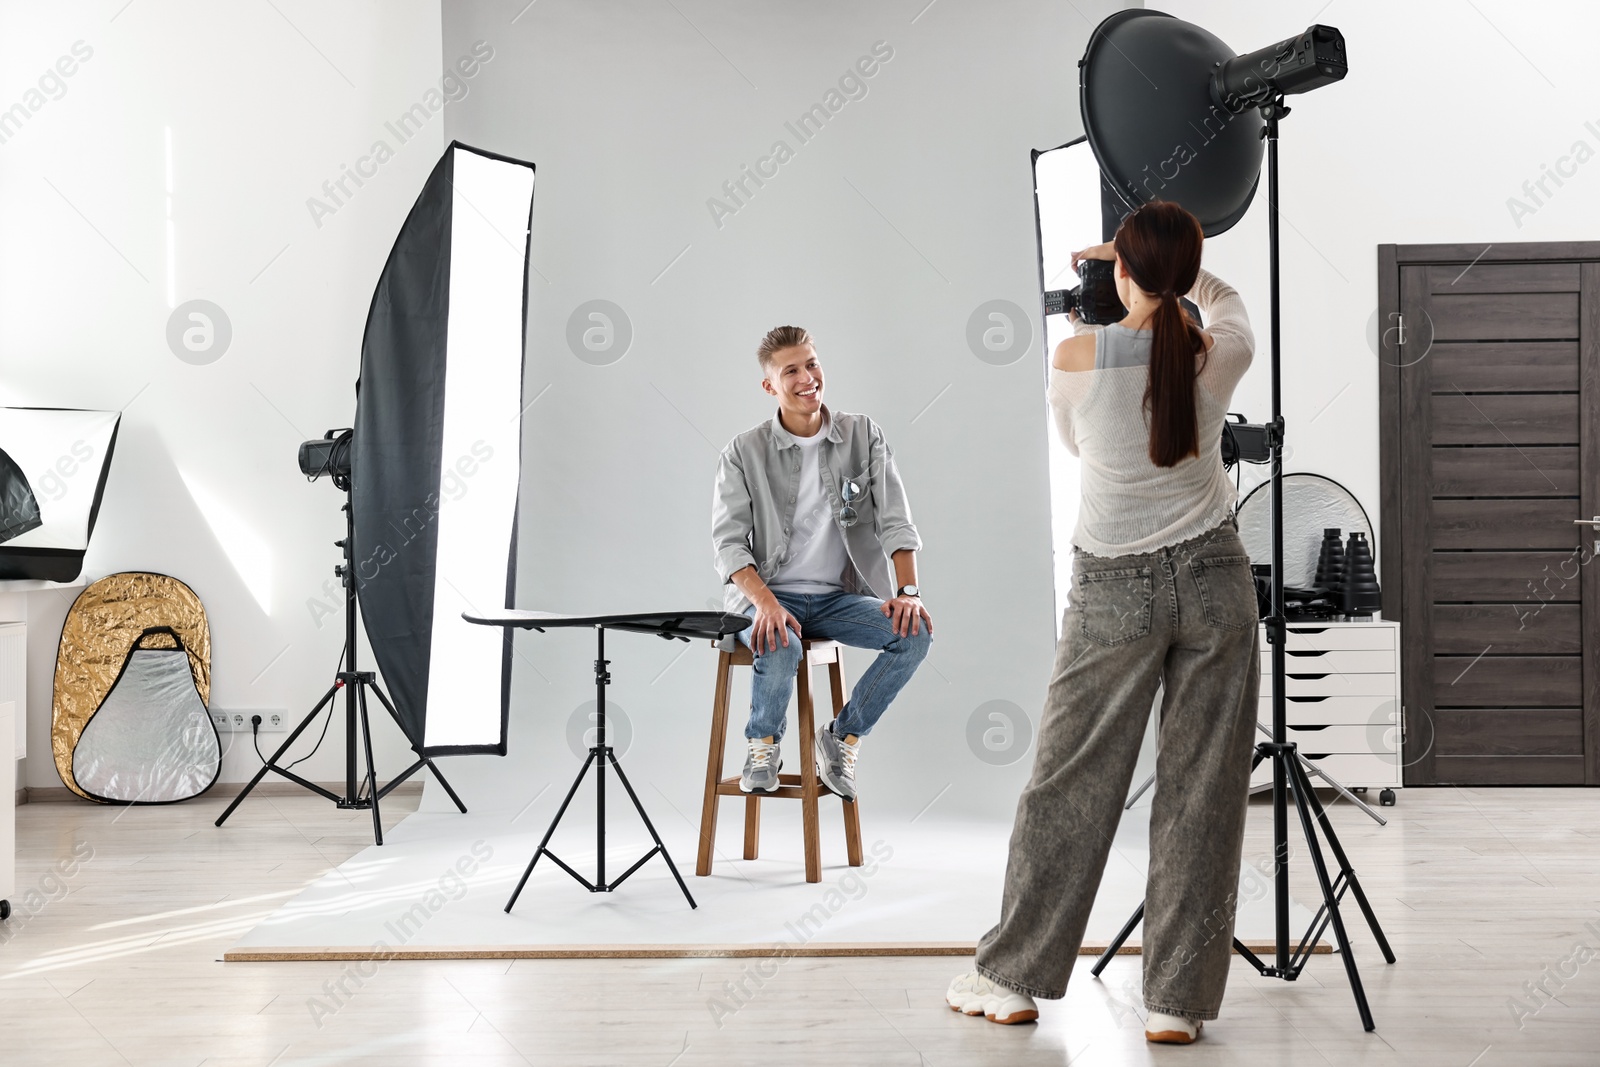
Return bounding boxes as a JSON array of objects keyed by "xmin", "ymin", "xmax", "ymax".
[{"xmin": 978, "ymin": 520, "xmax": 1261, "ymax": 1019}]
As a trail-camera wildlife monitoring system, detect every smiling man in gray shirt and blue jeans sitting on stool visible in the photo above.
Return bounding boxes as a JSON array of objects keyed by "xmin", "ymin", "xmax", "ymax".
[{"xmin": 712, "ymin": 326, "xmax": 933, "ymax": 801}]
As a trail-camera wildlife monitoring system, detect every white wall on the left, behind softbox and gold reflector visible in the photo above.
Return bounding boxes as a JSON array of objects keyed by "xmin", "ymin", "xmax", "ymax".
[{"xmin": 0, "ymin": 0, "xmax": 454, "ymax": 787}]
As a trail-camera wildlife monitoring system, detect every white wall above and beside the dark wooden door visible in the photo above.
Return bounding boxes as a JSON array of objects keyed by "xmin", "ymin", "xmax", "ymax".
[{"xmin": 1158, "ymin": 0, "xmax": 1600, "ymax": 563}]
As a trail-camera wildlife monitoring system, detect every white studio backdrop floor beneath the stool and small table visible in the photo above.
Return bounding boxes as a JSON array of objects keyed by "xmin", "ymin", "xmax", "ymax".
[{"xmin": 226, "ymin": 790, "xmax": 1310, "ymax": 961}]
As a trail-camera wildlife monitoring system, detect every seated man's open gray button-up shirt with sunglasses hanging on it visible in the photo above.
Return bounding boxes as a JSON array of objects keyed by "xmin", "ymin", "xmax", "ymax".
[{"xmin": 710, "ymin": 405, "xmax": 922, "ymax": 613}]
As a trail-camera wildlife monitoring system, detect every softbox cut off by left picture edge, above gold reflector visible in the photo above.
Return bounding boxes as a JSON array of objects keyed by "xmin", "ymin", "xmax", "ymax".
[{"xmin": 0, "ymin": 408, "xmax": 122, "ymax": 582}]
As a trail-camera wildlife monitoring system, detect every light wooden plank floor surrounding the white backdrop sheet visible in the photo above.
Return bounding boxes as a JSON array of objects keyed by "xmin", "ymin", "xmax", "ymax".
[{"xmin": 0, "ymin": 789, "xmax": 1600, "ymax": 1067}]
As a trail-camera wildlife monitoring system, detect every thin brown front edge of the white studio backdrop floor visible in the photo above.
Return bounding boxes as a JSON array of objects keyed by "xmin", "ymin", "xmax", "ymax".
[{"xmin": 222, "ymin": 941, "xmax": 1333, "ymax": 963}]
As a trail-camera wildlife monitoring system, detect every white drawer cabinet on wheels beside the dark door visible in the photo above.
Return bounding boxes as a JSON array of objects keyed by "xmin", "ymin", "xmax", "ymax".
[{"xmin": 1251, "ymin": 621, "xmax": 1405, "ymax": 800}]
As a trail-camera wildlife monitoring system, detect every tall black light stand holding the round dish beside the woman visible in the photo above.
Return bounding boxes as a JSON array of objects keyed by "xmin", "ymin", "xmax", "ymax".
[{"xmin": 1090, "ymin": 94, "xmax": 1395, "ymax": 1030}]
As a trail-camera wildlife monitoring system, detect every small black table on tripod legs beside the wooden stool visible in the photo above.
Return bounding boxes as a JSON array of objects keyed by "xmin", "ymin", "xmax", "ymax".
[{"xmin": 461, "ymin": 608, "xmax": 750, "ymax": 913}]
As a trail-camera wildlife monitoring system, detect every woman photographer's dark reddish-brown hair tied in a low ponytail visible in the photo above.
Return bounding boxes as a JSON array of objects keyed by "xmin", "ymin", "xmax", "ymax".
[{"xmin": 1114, "ymin": 200, "xmax": 1205, "ymax": 467}]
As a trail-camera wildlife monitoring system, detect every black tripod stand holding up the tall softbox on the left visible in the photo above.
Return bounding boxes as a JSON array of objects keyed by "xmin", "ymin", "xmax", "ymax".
[{"xmin": 216, "ymin": 483, "xmax": 467, "ymax": 845}]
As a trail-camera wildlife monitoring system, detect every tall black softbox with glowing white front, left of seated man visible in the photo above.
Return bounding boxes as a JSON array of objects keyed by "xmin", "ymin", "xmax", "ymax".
[{"xmin": 350, "ymin": 142, "xmax": 533, "ymax": 755}]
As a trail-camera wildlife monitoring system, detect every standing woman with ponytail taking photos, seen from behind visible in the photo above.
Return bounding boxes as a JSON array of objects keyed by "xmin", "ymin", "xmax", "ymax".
[{"xmin": 946, "ymin": 202, "xmax": 1261, "ymax": 1045}]
